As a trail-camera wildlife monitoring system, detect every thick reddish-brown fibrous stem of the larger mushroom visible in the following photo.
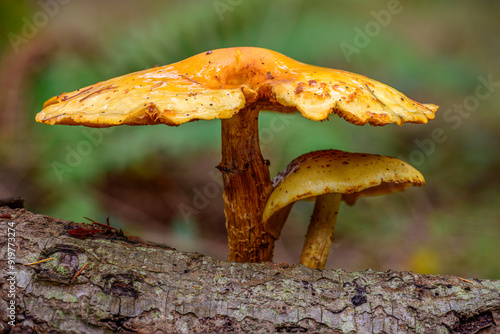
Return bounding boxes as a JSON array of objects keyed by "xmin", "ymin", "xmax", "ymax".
[{"xmin": 217, "ymin": 108, "xmax": 274, "ymax": 262}]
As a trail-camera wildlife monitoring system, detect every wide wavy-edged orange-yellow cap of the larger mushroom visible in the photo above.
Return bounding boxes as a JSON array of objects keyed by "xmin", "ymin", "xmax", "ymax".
[{"xmin": 36, "ymin": 47, "xmax": 438, "ymax": 127}]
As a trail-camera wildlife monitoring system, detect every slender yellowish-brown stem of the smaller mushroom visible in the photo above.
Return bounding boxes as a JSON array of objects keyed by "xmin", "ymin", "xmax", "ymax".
[{"xmin": 300, "ymin": 193, "xmax": 342, "ymax": 269}]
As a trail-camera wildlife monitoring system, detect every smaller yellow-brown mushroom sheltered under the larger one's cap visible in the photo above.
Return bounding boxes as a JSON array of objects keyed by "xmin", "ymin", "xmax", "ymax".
[{"xmin": 263, "ymin": 150, "xmax": 425, "ymax": 269}]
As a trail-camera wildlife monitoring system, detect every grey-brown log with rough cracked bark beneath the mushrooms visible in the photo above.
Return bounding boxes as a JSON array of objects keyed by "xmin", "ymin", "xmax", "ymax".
[{"xmin": 0, "ymin": 207, "xmax": 500, "ymax": 333}]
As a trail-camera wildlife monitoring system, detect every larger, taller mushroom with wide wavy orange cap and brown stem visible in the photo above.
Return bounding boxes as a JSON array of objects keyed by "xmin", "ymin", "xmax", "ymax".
[{"xmin": 36, "ymin": 47, "xmax": 437, "ymax": 262}]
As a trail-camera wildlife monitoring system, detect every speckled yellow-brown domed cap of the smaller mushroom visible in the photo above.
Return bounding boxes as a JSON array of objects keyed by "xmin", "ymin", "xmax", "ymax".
[{"xmin": 262, "ymin": 150, "xmax": 425, "ymax": 231}]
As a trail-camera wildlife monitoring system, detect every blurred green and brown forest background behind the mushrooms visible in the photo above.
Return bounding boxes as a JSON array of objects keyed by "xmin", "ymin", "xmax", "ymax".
[{"xmin": 0, "ymin": 0, "xmax": 500, "ymax": 278}]
